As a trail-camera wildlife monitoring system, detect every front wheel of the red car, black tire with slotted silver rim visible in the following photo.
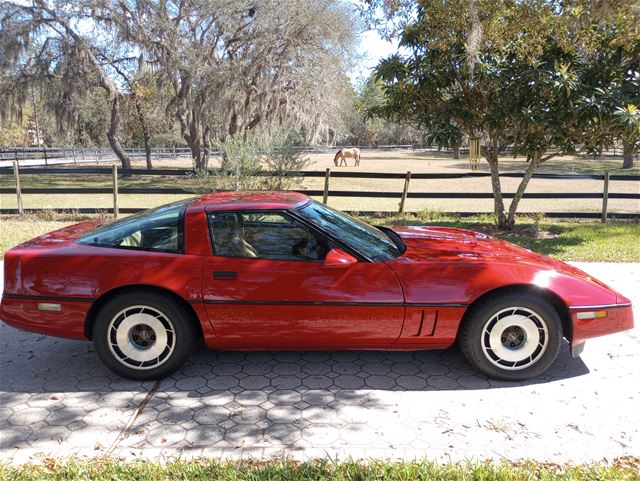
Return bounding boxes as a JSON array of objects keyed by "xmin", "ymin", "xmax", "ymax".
[{"xmin": 458, "ymin": 288, "xmax": 562, "ymax": 381}]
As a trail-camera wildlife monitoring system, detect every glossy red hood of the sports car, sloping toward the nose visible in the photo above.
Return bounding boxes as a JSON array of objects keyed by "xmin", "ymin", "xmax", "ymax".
[{"xmin": 392, "ymin": 226, "xmax": 604, "ymax": 285}]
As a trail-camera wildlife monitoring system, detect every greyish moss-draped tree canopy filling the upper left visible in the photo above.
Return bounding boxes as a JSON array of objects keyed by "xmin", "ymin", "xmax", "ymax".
[{"xmin": 0, "ymin": 0, "xmax": 357, "ymax": 169}]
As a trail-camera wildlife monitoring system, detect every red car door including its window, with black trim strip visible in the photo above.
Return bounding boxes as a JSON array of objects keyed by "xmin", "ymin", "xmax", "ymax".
[{"xmin": 203, "ymin": 211, "xmax": 404, "ymax": 349}]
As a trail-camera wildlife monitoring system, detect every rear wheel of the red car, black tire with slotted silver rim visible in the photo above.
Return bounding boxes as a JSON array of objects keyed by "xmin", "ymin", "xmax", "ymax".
[{"xmin": 93, "ymin": 291, "xmax": 197, "ymax": 381}]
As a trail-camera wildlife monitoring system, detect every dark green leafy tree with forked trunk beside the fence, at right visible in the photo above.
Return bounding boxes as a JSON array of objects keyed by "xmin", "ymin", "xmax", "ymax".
[{"xmin": 373, "ymin": 0, "xmax": 640, "ymax": 228}]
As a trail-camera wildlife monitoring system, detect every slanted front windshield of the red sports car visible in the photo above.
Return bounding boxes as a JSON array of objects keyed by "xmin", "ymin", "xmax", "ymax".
[{"xmin": 298, "ymin": 201, "xmax": 403, "ymax": 261}]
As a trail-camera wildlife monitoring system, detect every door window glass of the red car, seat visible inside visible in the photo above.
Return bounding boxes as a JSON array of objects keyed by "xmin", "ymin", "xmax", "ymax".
[{"xmin": 209, "ymin": 212, "xmax": 335, "ymax": 261}]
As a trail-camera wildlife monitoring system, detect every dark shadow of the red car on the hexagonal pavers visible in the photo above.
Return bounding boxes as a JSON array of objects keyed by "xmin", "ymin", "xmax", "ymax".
[{"xmin": 0, "ymin": 325, "xmax": 589, "ymax": 394}]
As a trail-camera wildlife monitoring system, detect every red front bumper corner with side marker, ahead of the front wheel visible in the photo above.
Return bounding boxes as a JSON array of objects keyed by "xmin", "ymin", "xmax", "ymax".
[{"xmin": 569, "ymin": 304, "xmax": 633, "ymax": 347}]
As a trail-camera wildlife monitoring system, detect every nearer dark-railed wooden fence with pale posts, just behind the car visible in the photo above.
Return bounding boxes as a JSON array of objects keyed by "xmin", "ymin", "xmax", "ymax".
[{"xmin": 0, "ymin": 161, "xmax": 640, "ymax": 222}]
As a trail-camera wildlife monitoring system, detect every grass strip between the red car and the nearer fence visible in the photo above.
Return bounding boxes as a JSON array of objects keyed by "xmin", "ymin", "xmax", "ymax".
[{"xmin": 0, "ymin": 212, "xmax": 640, "ymax": 262}]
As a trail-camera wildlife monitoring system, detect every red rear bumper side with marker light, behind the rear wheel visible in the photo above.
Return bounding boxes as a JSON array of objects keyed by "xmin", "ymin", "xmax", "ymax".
[{"xmin": 0, "ymin": 295, "xmax": 91, "ymax": 339}]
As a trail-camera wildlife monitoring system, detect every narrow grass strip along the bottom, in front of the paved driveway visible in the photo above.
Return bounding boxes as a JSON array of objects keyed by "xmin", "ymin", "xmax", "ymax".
[{"xmin": 0, "ymin": 458, "xmax": 640, "ymax": 481}]
